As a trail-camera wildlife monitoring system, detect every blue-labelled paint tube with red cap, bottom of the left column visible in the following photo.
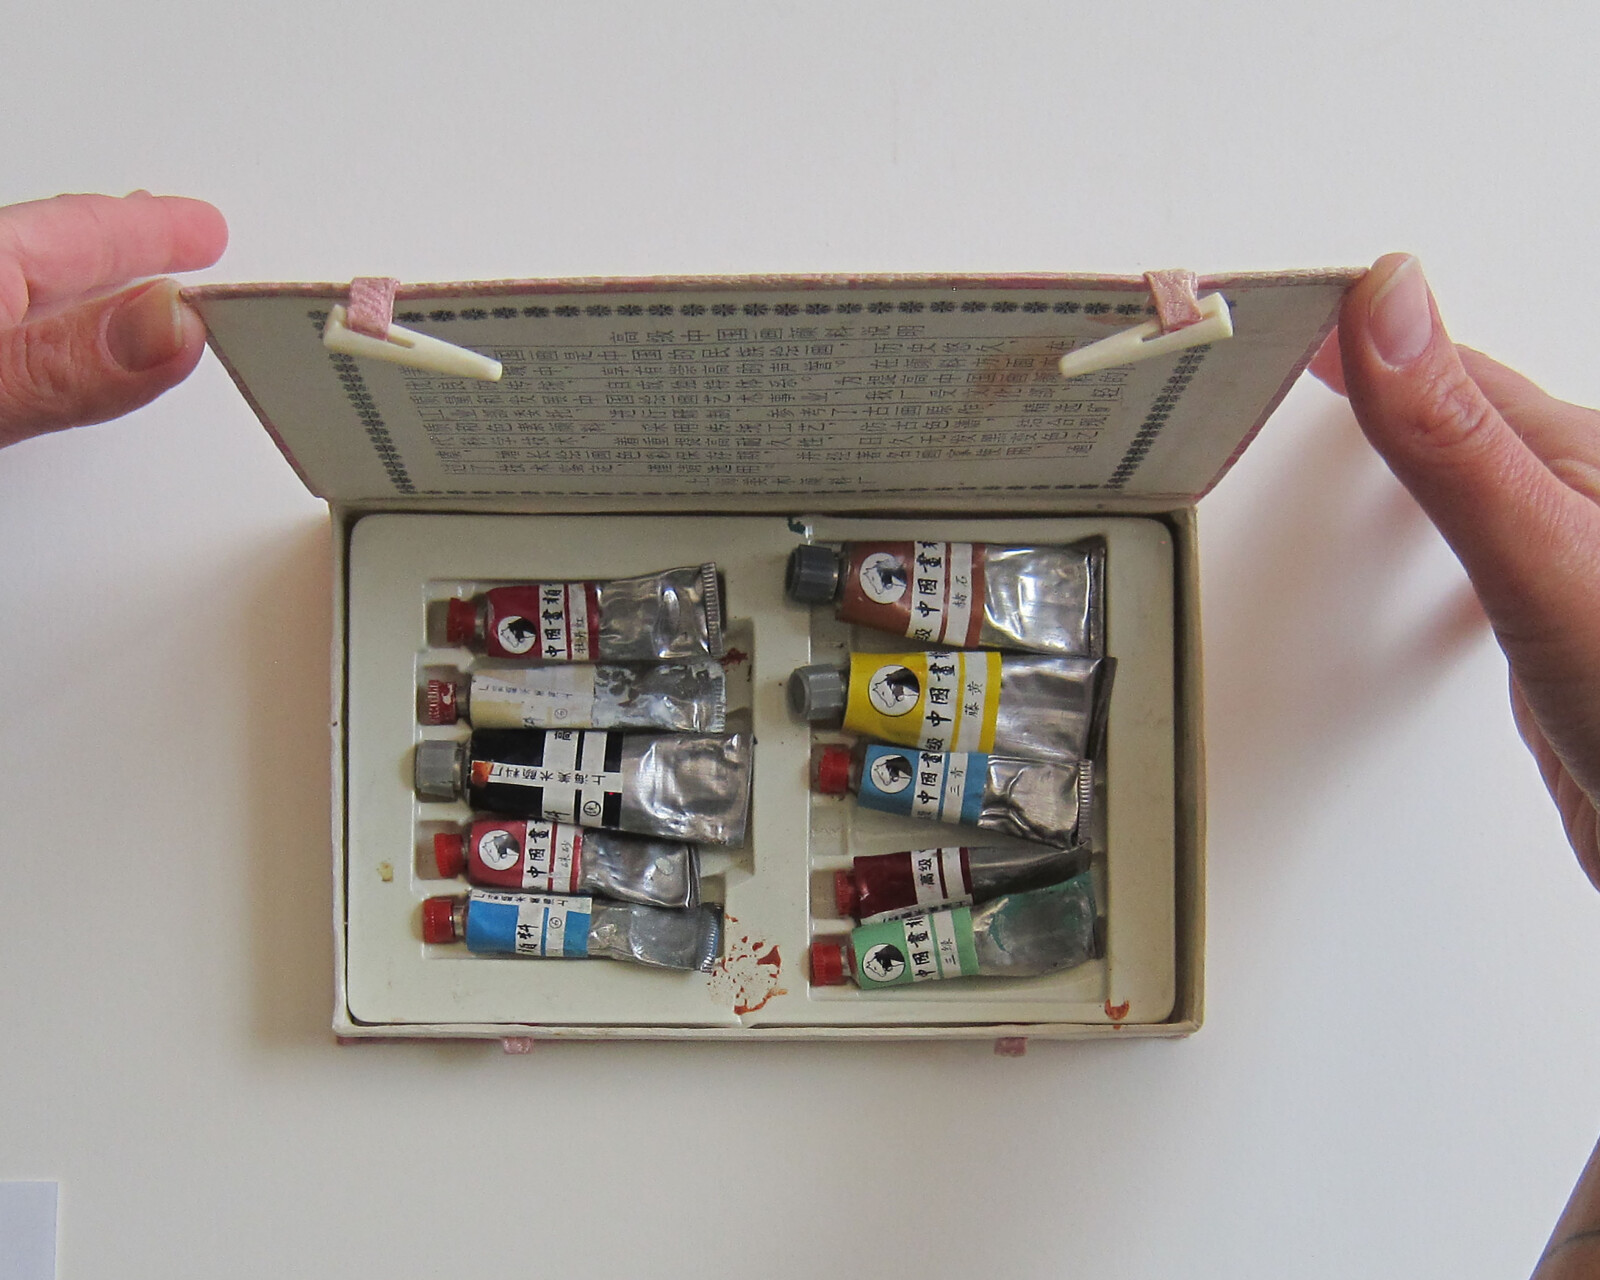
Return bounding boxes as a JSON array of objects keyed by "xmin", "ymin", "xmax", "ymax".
[{"xmin": 422, "ymin": 890, "xmax": 722, "ymax": 973}]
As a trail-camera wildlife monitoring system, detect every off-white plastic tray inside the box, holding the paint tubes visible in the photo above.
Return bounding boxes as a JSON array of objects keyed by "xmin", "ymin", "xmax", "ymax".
[{"xmin": 344, "ymin": 514, "xmax": 1176, "ymax": 1037}]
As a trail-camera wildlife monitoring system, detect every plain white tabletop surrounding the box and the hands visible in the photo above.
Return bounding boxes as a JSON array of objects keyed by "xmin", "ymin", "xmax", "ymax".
[{"xmin": 0, "ymin": 0, "xmax": 1600, "ymax": 1278}]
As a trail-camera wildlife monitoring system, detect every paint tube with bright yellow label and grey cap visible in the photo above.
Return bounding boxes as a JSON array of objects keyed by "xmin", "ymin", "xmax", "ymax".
[{"xmin": 789, "ymin": 650, "xmax": 1115, "ymax": 763}]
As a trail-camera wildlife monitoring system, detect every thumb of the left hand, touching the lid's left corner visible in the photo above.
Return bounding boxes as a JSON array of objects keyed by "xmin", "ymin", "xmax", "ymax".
[{"xmin": 0, "ymin": 280, "xmax": 205, "ymax": 445}]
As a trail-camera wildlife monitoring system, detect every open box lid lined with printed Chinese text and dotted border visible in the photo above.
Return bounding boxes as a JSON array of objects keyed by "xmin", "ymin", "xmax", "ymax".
[{"xmin": 186, "ymin": 270, "xmax": 1360, "ymax": 510}]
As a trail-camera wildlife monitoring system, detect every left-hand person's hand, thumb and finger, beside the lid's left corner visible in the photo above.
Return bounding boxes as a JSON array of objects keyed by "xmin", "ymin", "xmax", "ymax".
[{"xmin": 0, "ymin": 190, "xmax": 227, "ymax": 446}]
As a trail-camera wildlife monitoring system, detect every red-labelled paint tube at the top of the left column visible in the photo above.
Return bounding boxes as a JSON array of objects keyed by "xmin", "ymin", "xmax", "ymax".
[{"xmin": 434, "ymin": 565, "xmax": 723, "ymax": 662}]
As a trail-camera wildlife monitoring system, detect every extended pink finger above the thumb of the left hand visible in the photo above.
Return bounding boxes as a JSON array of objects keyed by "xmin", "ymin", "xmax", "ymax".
[{"xmin": 0, "ymin": 190, "xmax": 227, "ymax": 330}]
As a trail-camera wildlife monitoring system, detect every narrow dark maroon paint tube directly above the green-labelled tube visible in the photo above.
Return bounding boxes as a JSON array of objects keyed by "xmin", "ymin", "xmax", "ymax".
[{"xmin": 834, "ymin": 845, "xmax": 1090, "ymax": 920}]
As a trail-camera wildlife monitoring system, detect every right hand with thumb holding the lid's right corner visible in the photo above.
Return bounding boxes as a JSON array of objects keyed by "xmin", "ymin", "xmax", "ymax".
[{"xmin": 1312, "ymin": 254, "xmax": 1600, "ymax": 888}]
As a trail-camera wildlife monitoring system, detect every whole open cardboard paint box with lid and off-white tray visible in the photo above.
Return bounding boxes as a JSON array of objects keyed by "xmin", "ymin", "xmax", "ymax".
[{"xmin": 187, "ymin": 270, "xmax": 1357, "ymax": 1046}]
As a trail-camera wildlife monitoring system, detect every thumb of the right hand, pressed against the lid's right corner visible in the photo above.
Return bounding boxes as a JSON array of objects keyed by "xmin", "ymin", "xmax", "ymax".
[{"xmin": 1339, "ymin": 254, "xmax": 1600, "ymax": 665}]
